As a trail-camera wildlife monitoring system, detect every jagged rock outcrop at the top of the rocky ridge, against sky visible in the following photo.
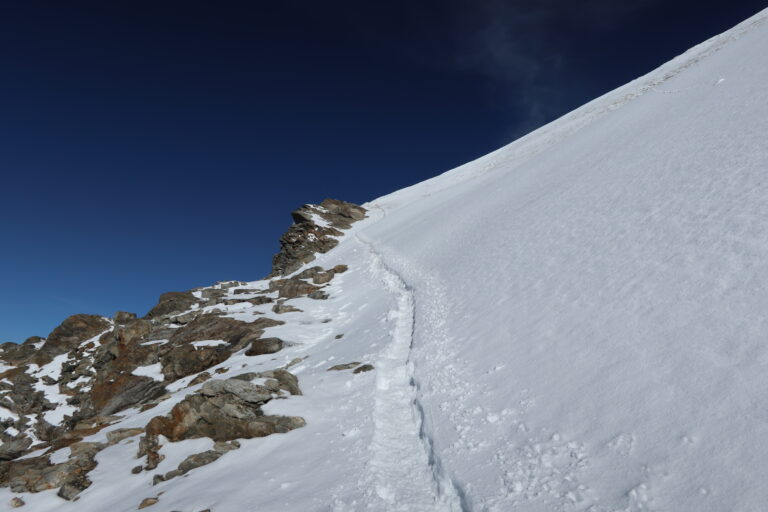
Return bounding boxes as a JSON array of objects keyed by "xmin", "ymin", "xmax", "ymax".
[{"xmin": 269, "ymin": 199, "xmax": 365, "ymax": 277}]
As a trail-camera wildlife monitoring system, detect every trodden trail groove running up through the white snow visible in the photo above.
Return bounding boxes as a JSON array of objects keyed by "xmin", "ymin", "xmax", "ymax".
[{"xmin": 356, "ymin": 237, "xmax": 468, "ymax": 511}]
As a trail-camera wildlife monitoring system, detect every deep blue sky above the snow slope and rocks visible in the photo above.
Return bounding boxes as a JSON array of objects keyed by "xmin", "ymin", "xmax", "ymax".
[{"xmin": 0, "ymin": 0, "xmax": 766, "ymax": 341}]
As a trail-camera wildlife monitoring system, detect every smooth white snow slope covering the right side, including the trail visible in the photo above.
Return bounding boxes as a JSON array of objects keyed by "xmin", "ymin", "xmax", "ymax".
[{"xmin": 6, "ymin": 11, "xmax": 768, "ymax": 512}]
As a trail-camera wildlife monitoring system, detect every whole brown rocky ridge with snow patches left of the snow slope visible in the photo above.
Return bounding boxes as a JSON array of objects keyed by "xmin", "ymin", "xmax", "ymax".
[{"xmin": 0, "ymin": 199, "xmax": 365, "ymax": 503}]
